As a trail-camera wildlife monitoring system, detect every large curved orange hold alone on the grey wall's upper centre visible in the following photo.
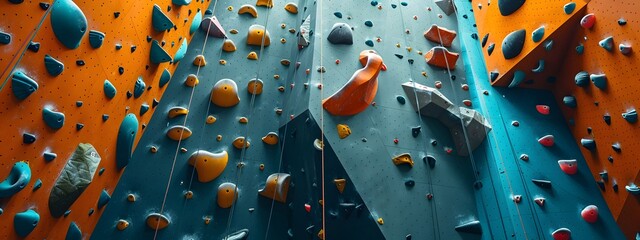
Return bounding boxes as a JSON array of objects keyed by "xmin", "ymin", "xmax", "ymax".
[{"xmin": 322, "ymin": 50, "xmax": 387, "ymax": 116}]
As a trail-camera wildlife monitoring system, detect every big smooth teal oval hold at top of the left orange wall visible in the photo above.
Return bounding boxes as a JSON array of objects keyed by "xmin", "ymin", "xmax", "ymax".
[{"xmin": 50, "ymin": 0, "xmax": 87, "ymax": 49}]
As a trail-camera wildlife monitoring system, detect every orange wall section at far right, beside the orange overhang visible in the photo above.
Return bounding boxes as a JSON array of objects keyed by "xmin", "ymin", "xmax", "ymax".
[{"xmin": 554, "ymin": 0, "xmax": 640, "ymax": 239}]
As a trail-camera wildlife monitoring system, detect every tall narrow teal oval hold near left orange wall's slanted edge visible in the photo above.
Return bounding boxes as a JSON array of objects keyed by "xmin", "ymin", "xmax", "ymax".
[{"xmin": 116, "ymin": 113, "xmax": 138, "ymax": 169}]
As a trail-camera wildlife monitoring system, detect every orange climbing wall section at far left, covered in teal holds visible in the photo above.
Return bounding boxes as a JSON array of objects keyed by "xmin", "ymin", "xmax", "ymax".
[{"xmin": 0, "ymin": 0, "xmax": 209, "ymax": 239}]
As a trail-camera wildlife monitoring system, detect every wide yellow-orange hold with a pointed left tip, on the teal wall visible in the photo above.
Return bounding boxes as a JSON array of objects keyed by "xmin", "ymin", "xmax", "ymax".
[{"xmin": 188, "ymin": 150, "xmax": 229, "ymax": 183}]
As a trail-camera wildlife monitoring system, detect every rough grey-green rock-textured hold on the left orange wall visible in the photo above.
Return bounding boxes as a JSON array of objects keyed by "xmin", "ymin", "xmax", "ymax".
[{"xmin": 49, "ymin": 143, "xmax": 101, "ymax": 218}]
